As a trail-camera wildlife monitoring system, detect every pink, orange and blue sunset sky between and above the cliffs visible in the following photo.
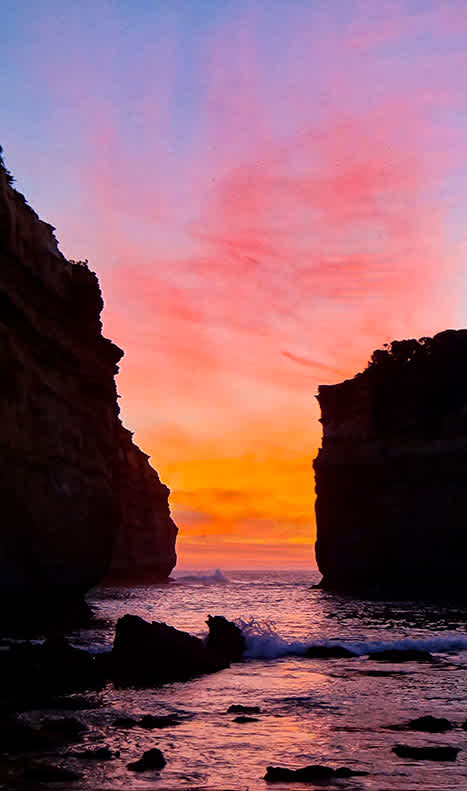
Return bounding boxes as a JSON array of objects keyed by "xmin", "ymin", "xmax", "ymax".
[{"xmin": 0, "ymin": 0, "xmax": 467, "ymax": 569}]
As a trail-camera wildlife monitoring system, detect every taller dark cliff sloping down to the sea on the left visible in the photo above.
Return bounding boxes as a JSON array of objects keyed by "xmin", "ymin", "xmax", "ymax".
[{"xmin": 0, "ymin": 149, "xmax": 175, "ymax": 598}]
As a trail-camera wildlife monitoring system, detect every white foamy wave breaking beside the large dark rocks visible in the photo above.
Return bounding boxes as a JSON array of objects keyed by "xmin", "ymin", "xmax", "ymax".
[{"xmin": 236, "ymin": 618, "xmax": 467, "ymax": 659}]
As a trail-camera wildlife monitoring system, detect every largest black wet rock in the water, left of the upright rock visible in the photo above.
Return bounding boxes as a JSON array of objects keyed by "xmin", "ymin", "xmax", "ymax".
[{"xmin": 111, "ymin": 615, "xmax": 229, "ymax": 684}]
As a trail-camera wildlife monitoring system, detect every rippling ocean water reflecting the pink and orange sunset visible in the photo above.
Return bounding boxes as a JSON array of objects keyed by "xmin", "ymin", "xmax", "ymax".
[{"xmin": 59, "ymin": 571, "xmax": 467, "ymax": 791}]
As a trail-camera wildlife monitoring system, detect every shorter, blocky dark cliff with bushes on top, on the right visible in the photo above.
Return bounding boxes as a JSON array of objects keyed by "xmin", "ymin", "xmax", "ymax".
[{"xmin": 314, "ymin": 330, "xmax": 467, "ymax": 597}]
